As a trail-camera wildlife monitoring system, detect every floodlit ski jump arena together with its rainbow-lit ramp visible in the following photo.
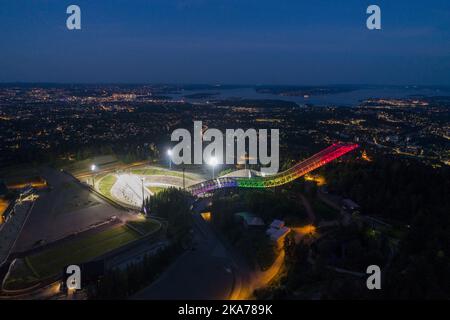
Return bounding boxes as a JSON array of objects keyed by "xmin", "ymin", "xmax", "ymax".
[{"xmin": 96, "ymin": 143, "xmax": 358, "ymax": 208}]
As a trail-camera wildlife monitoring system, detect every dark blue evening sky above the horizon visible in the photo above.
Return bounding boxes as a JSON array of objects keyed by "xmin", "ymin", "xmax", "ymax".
[{"xmin": 0, "ymin": 0, "xmax": 450, "ymax": 85}]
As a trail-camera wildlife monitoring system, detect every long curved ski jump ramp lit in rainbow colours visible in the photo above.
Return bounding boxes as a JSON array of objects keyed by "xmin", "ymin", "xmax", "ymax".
[{"xmin": 187, "ymin": 143, "xmax": 358, "ymax": 196}]
